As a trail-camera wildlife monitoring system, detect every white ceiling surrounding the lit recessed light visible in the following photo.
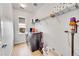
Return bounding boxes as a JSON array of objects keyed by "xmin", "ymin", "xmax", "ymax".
[{"xmin": 12, "ymin": 3, "xmax": 44, "ymax": 13}]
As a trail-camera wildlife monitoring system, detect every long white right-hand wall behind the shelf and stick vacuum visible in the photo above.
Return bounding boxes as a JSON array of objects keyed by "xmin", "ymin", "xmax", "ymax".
[{"xmin": 35, "ymin": 4, "xmax": 79, "ymax": 56}]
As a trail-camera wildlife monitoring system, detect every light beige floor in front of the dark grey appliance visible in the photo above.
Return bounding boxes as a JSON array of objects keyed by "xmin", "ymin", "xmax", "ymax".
[{"xmin": 12, "ymin": 43, "xmax": 42, "ymax": 56}]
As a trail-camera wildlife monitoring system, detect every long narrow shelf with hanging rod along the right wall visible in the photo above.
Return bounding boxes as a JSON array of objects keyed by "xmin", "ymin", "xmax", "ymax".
[{"xmin": 33, "ymin": 3, "xmax": 79, "ymax": 23}]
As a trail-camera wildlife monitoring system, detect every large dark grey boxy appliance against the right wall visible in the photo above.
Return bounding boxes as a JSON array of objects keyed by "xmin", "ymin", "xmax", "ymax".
[{"xmin": 30, "ymin": 32, "xmax": 42, "ymax": 51}]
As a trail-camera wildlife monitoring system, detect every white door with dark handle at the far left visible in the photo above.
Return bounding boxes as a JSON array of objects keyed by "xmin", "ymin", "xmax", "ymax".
[{"xmin": 0, "ymin": 3, "xmax": 14, "ymax": 56}]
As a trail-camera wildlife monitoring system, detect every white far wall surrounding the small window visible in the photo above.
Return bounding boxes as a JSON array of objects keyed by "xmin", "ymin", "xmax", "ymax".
[{"xmin": 14, "ymin": 9, "xmax": 33, "ymax": 44}]
